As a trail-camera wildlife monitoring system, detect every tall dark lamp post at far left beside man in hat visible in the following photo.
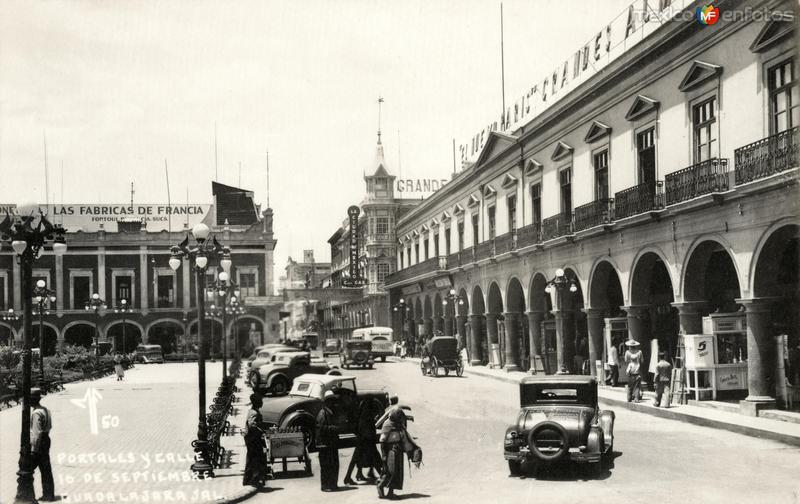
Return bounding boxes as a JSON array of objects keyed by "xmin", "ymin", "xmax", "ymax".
[{"xmin": 0, "ymin": 205, "xmax": 67, "ymax": 503}]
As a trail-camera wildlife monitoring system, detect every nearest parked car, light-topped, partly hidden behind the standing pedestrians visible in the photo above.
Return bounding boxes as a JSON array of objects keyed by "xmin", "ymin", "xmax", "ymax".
[{"xmin": 260, "ymin": 374, "xmax": 397, "ymax": 451}]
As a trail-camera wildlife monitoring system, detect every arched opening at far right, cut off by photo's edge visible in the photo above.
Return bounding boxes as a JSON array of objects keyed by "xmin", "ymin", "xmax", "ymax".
[{"xmin": 745, "ymin": 224, "xmax": 800, "ymax": 409}]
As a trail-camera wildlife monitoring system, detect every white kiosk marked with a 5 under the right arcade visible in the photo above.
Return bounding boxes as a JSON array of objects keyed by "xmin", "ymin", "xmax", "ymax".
[{"xmin": 683, "ymin": 312, "xmax": 747, "ymax": 400}]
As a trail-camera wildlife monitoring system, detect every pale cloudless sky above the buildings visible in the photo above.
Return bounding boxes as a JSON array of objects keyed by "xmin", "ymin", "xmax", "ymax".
[{"xmin": 0, "ymin": 0, "xmax": 631, "ymax": 275}]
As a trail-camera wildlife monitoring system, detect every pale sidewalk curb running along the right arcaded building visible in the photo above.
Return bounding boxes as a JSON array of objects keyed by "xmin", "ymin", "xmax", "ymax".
[{"xmin": 398, "ymin": 357, "xmax": 800, "ymax": 446}]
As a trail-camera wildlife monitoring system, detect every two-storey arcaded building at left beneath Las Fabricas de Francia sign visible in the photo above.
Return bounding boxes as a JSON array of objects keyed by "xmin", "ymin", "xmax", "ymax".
[{"xmin": 0, "ymin": 183, "xmax": 280, "ymax": 355}]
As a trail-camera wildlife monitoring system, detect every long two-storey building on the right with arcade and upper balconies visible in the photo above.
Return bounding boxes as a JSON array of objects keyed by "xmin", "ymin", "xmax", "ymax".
[{"xmin": 386, "ymin": 1, "xmax": 800, "ymax": 413}]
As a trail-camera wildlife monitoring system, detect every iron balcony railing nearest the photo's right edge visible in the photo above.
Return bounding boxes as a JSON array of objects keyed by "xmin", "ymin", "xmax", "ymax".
[{"xmin": 734, "ymin": 127, "xmax": 800, "ymax": 185}]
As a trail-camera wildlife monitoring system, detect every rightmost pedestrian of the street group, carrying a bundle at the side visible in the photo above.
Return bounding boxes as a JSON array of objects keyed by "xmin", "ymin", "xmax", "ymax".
[{"xmin": 377, "ymin": 406, "xmax": 422, "ymax": 499}]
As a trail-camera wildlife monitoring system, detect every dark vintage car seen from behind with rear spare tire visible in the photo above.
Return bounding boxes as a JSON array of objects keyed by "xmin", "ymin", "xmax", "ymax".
[{"xmin": 503, "ymin": 375, "xmax": 615, "ymax": 476}]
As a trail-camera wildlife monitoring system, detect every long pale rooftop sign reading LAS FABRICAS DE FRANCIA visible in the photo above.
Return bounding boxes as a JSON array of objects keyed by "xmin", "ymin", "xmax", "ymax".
[{"xmin": 0, "ymin": 203, "xmax": 211, "ymax": 233}]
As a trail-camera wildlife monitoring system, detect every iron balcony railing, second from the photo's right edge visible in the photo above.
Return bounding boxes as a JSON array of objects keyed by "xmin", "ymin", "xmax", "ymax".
[{"xmin": 664, "ymin": 158, "xmax": 730, "ymax": 206}]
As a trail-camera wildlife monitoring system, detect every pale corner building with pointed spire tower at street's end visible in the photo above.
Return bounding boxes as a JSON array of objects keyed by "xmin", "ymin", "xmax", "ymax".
[{"xmin": 315, "ymin": 139, "xmax": 420, "ymax": 338}]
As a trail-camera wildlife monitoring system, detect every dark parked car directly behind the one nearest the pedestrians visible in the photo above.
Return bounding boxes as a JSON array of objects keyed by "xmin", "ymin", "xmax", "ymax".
[{"xmin": 249, "ymin": 351, "xmax": 333, "ymax": 395}]
